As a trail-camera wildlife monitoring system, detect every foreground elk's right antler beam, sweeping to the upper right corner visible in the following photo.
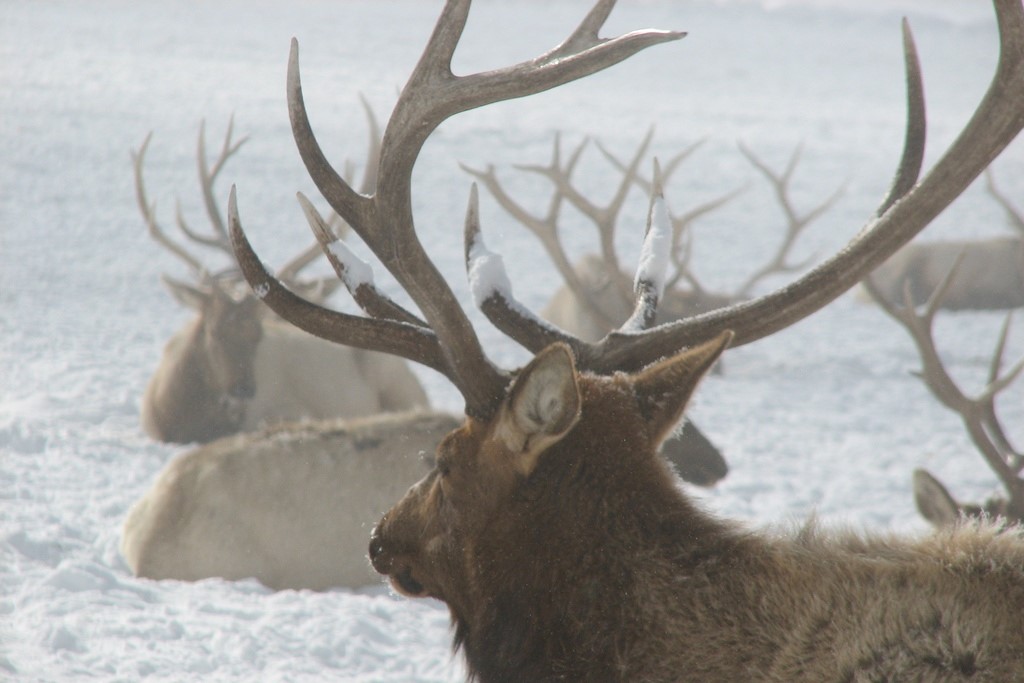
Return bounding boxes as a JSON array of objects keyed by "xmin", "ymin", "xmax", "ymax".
[{"xmin": 581, "ymin": 0, "xmax": 1024, "ymax": 372}]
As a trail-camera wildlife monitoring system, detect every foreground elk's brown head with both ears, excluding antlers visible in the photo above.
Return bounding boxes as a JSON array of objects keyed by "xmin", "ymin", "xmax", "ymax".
[{"xmin": 370, "ymin": 332, "xmax": 732, "ymax": 611}]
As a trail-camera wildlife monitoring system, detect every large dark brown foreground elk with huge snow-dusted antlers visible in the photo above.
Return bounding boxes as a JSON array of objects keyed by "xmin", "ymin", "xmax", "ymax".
[{"xmin": 228, "ymin": 0, "xmax": 1024, "ymax": 682}]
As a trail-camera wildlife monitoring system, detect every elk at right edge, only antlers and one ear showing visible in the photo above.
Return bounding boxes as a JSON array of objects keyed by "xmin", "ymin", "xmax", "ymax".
[{"xmin": 864, "ymin": 254, "xmax": 1024, "ymax": 526}]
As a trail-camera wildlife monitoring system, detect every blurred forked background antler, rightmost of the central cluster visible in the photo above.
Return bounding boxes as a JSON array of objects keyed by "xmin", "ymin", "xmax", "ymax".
[{"xmin": 737, "ymin": 143, "xmax": 843, "ymax": 298}]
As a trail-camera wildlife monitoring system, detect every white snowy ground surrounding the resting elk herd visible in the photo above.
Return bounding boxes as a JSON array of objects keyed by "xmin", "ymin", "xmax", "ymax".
[{"xmin": 0, "ymin": 0, "xmax": 1024, "ymax": 681}]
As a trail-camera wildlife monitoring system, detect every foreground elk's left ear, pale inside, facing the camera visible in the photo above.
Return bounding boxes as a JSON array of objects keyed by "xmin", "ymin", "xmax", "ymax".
[{"xmin": 497, "ymin": 344, "xmax": 581, "ymax": 475}]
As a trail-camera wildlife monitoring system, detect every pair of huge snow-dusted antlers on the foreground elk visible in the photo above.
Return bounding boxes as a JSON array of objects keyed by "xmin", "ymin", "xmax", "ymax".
[{"xmin": 229, "ymin": 0, "xmax": 1024, "ymax": 417}]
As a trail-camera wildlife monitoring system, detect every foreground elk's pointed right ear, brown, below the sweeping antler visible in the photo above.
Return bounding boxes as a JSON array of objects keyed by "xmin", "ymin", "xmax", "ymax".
[{"xmin": 633, "ymin": 330, "xmax": 733, "ymax": 444}]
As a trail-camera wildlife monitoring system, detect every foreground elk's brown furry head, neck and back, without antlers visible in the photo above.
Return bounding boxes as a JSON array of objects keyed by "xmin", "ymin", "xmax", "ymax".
[{"xmin": 370, "ymin": 335, "xmax": 1024, "ymax": 683}]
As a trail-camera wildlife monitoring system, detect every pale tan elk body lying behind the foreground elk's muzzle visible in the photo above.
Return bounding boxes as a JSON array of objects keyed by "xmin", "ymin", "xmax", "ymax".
[{"xmin": 121, "ymin": 412, "xmax": 459, "ymax": 591}]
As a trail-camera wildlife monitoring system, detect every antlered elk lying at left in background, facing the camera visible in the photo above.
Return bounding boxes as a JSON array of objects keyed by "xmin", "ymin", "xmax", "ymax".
[{"xmin": 132, "ymin": 120, "xmax": 428, "ymax": 443}]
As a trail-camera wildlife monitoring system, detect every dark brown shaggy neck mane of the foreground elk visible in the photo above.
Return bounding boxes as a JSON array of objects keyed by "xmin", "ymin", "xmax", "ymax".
[{"xmin": 452, "ymin": 378, "xmax": 740, "ymax": 682}]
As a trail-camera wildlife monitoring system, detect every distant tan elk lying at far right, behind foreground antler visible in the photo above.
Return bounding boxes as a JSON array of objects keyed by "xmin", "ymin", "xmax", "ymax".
[{"xmin": 865, "ymin": 170, "xmax": 1024, "ymax": 310}]
